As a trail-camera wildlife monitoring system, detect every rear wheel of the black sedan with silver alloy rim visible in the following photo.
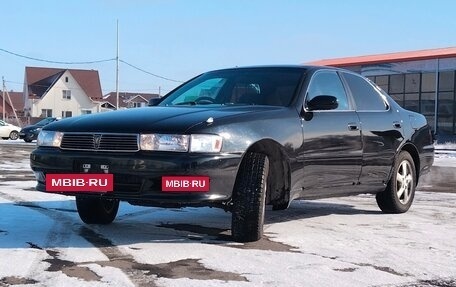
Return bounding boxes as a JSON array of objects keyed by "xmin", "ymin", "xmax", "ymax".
[{"xmin": 375, "ymin": 151, "xmax": 417, "ymax": 213}]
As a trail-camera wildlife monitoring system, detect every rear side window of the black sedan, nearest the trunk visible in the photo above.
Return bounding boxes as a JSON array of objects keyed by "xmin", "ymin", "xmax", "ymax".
[{"xmin": 343, "ymin": 73, "xmax": 388, "ymax": 111}]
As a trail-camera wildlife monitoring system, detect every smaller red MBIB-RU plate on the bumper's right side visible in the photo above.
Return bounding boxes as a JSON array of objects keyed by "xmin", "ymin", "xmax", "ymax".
[{"xmin": 162, "ymin": 176, "xmax": 210, "ymax": 192}]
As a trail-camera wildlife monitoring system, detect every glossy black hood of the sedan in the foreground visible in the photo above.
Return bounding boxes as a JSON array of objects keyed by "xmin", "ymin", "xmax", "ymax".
[{"xmin": 43, "ymin": 106, "xmax": 282, "ymax": 133}]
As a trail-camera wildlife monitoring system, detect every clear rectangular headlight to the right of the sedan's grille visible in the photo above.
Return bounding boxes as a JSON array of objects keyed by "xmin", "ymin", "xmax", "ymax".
[{"xmin": 140, "ymin": 134, "xmax": 222, "ymax": 152}]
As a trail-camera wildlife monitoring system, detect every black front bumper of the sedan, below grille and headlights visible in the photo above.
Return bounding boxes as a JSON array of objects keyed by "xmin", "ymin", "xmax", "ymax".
[{"xmin": 30, "ymin": 147, "xmax": 241, "ymax": 207}]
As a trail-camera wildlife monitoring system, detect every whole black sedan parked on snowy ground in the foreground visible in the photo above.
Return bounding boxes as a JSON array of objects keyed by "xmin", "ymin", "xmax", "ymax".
[{"xmin": 31, "ymin": 66, "xmax": 434, "ymax": 242}]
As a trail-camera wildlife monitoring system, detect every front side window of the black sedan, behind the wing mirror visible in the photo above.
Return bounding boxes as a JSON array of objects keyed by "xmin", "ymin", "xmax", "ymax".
[{"xmin": 306, "ymin": 71, "xmax": 349, "ymax": 110}]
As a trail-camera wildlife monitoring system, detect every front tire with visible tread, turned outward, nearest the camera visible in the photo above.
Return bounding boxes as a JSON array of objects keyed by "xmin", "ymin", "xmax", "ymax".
[{"xmin": 231, "ymin": 152, "xmax": 269, "ymax": 242}]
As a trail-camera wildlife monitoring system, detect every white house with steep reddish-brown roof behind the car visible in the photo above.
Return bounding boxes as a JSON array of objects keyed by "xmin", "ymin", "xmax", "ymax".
[{"xmin": 23, "ymin": 67, "xmax": 103, "ymax": 118}]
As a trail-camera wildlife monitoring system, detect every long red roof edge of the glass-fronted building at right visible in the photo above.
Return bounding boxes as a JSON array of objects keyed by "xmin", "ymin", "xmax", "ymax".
[{"xmin": 308, "ymin": 47, "xmax": 456, "ymax": 67}]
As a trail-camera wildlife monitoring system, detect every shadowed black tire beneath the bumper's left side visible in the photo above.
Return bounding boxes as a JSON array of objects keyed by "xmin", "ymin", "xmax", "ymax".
[{"xmin": 76, "ymin": 196, "xmax": 119, "ymax": 224}]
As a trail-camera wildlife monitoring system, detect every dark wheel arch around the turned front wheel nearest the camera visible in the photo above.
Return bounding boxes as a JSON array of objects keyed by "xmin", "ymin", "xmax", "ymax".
[{"xmin": 239, "ymin": 139, "xmax": 291, "ymax": 205}]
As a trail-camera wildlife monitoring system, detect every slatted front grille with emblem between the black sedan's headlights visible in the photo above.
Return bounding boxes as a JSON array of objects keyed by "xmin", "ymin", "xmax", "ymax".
[{"xmin": 60, "ymin": 133, "xmax": 139, "ymax": 152}]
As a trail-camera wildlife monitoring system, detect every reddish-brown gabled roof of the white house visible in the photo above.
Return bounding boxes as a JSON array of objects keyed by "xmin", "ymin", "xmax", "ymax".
[{"xmin": 25, "ymin": 67, "xmax": 103, "ymax": 101}]
